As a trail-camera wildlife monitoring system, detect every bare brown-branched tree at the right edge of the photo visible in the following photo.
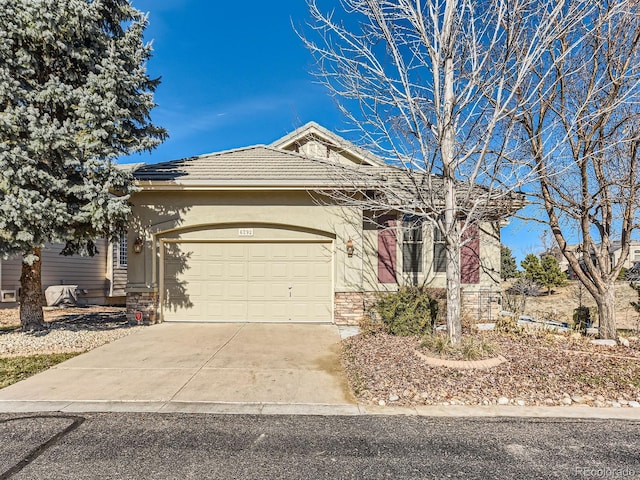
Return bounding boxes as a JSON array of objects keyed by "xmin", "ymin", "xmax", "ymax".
[{"xmin": 510, "ymin": 0, "xmax": 640, "ymax": 338}]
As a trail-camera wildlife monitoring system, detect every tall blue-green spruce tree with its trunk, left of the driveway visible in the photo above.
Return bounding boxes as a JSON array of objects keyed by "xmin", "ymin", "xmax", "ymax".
[{"xmin": 0, "ymin": 0, "xmax": 166, "ymax": 330}]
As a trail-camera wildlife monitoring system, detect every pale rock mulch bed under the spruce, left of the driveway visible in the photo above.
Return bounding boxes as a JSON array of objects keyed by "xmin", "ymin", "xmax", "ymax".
[{"xmin": 0, "ymin": 306, "xmax": 143, "ymax": 357}]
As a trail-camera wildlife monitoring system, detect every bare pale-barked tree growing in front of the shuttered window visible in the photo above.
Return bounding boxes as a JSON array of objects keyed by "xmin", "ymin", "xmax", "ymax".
[{"xmin": 301, "ymin": 0, "xmax": 588, "ymax": 343}]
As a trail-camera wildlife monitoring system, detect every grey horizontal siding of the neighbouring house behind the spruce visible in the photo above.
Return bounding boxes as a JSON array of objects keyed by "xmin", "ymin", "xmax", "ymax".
[{"xmin": 2, "ymin": 239, "xmax": 108, "ymax": 303}]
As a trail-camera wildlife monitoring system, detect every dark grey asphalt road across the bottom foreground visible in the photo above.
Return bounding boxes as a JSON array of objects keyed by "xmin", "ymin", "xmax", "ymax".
[{"xmin": 0, "ymin": 413, "xmax": 640, "ymax": 480}]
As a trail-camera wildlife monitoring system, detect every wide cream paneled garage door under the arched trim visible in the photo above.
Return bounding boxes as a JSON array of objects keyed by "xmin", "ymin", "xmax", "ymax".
[{"xmin": 163, "ymin": 242, "xmax": 332, "ymax": 322}]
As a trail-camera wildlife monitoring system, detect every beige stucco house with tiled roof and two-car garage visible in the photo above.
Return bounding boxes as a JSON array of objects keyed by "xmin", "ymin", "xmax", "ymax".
[{"xmin": 126, "ymin": 123, "xmax": 516, "ymax": 323}]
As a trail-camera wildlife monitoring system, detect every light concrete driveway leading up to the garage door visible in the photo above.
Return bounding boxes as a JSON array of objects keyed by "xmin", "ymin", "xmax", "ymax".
[{"xmin": 0, "ymin": 323, "xmax": 355, "ymax": 412}]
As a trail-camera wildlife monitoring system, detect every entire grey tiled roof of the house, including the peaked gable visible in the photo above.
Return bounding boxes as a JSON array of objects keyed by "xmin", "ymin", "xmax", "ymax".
[{"xmin": 133, "ymin": 122, "xmax": 524, "ymax": 215}]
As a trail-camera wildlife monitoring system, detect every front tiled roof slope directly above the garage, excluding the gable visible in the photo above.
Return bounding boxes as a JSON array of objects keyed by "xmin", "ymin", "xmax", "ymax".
[{"xmin": 134, "ymin": 145, "xmax": 380, "ymax": 189}]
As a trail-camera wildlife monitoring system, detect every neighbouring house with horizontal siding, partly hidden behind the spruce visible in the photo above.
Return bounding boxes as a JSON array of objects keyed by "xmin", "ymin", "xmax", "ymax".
[{"xmin": 0, "ymin": 238, "xmax": 128, "ymax": 305}]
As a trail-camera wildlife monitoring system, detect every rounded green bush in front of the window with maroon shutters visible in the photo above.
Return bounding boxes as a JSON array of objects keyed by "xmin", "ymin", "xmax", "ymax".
[{"xmin": 375, "ymin": 287, "xmax": 438, "ymax": 336}]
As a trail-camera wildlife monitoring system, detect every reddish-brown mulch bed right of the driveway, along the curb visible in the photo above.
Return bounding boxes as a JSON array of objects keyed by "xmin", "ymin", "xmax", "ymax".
[{"xmin": 342, "ymin": 332, "xmax": 640, "ymax": 407}]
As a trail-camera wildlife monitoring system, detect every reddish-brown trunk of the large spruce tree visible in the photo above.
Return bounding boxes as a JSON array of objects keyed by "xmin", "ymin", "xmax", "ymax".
[{"xmin": 20, "ymin": 248, "xmax": 45, "ymax": 331}]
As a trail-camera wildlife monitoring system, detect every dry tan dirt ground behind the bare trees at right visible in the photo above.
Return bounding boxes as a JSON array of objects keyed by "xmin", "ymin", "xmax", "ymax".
[{"xmin": 503, "ymin": 281, "xmax": 640, "ymax": 332}]
